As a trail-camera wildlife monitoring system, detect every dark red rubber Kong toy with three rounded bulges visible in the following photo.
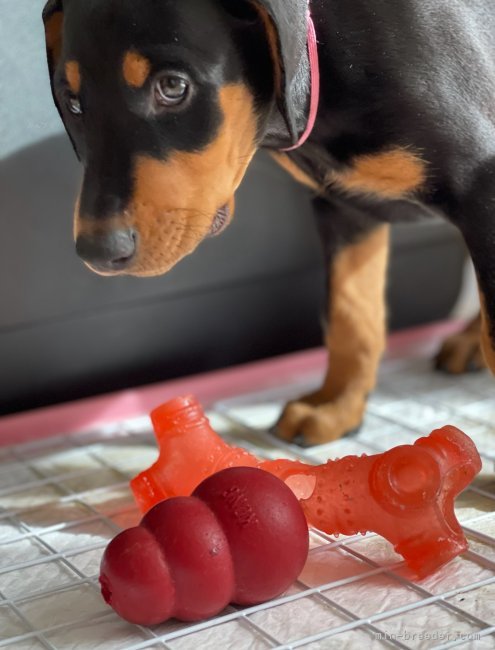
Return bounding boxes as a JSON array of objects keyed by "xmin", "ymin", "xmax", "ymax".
[{"xmin": 100, "ymin": 467, "xmax": 309, "ymax": 625}]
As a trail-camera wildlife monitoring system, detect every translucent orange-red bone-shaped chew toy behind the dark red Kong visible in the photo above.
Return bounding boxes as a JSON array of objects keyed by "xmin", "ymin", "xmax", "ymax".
[{"xmin": 131, "ymin": 397, "xmax": 481, "ymax": 577}]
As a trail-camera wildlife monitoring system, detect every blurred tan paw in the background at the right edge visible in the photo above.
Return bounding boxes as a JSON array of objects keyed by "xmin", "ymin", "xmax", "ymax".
[{"xmin": 434, "ymin": 330, "xmax": 486, "ymax": 375}]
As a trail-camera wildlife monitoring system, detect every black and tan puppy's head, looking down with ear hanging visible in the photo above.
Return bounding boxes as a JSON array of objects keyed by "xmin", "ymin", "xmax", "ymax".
[{"xmin": 43, "ymin": 0, "xmax": 312, "ymax": 276}]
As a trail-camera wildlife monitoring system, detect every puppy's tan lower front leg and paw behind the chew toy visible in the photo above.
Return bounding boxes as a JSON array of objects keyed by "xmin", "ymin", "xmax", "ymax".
[{"xmin": 277, "ymin": 226, "xmax": 389, "ymax": 445}]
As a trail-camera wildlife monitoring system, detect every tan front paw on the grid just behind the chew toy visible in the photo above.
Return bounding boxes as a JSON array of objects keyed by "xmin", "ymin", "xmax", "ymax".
[{"xmin": 274, "ymin": 398, "xmax": 365, "ymax": 446}]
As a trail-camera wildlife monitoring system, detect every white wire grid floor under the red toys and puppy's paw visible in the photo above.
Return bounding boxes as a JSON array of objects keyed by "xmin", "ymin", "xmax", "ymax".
[{"xmin": 0, "ymin": 350, "xmax": 495, "ymax": 650}]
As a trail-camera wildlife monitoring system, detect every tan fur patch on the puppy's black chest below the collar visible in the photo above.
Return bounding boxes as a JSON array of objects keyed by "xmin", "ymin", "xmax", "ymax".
[{"xmin": 327, "ymin": 148, "xmax": 426, "ymax": 199}]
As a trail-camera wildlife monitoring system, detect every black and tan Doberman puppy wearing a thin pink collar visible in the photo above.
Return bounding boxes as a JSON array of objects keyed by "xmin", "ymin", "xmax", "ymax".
[{"xmin": 44, "ymin": 0, "xmax": 495, "ymax": 444}]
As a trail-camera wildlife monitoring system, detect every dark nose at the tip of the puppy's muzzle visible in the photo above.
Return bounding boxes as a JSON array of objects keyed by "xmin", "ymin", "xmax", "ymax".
[{"xmin": 76, "ymin": 230, "xmax": 136, "ymax": 272}]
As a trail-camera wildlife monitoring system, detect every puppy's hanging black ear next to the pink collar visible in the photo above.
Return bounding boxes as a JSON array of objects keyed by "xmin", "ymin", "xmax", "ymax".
[{"xmin": 253, "ymin": 0, "xmax": 310, "ymax": 148}]
